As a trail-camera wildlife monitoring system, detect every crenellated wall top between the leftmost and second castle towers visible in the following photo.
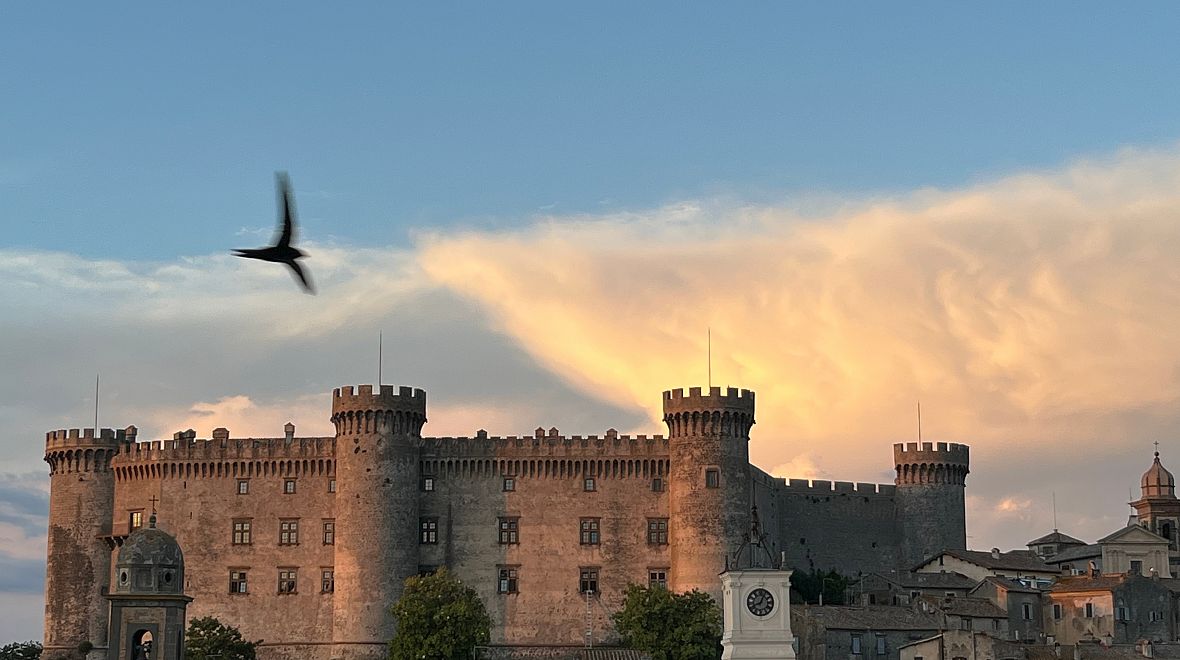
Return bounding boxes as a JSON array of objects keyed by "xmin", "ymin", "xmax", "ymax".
[{"xmin": 112, "ymin": 438, "xmax": 336, "ymax": 466}]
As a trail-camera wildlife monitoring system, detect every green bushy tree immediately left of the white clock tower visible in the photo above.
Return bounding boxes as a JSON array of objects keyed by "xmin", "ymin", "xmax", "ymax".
[{"xmin": 611, "ymin": 584, "xmax": 721, "ymax": 660}]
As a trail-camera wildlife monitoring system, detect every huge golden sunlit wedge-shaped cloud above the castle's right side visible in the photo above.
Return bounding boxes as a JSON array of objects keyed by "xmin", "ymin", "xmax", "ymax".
[{"xmin": 420, "ymin": 145, "xmax": 1180, "ymax": 552}]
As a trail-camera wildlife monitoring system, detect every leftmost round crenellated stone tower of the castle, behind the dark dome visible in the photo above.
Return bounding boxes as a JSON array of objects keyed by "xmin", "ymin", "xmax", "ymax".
[{"xmin": 44, "ymin": 429, "xmax": 123, "ymax": 659}]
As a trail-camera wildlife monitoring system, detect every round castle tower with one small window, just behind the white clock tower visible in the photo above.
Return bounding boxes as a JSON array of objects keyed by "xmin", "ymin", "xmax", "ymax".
[{"xmin": 663, "ymin": 387, "xmax": 754, "ymax": 602}]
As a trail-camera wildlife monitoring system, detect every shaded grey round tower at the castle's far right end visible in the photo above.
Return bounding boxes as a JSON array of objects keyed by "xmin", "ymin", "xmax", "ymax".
[{"xmin": 893, "ymin": 443, "xmax": 971, "ymax": 569}]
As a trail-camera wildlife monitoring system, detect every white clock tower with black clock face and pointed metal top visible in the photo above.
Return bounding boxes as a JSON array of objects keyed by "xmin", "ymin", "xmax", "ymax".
[{"xmin": 721, "ymin": 508, "xmax": 795, "ymax": 660}]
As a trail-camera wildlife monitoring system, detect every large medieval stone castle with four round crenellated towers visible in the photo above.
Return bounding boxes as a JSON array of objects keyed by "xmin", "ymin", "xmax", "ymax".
[{"xmin": 45, "ymin": 385, "xmax": 969, "ymax": 660}]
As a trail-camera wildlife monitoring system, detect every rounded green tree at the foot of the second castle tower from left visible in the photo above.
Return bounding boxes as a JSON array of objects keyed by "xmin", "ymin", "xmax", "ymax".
[{"xmin": 389, "ymin": 568, "xmax": 492, "ymax": 660}]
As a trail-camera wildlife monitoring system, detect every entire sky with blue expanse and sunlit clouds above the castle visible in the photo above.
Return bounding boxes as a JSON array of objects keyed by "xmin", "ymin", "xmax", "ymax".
[{"xmin": 0, "ymin": 2, "xmax": 1180, "ymax": 641}]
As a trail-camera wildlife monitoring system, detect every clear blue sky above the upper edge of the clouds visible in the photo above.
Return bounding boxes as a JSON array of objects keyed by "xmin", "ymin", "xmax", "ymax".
[{"xmin": 0, "ymin": 2, "xmax": 1180, "ymax": 260}]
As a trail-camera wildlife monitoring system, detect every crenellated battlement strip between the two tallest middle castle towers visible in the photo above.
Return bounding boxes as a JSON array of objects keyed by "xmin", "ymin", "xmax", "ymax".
[{"xmin": 422, "ymin": 429, "xmax": 668, "ymax": 458}]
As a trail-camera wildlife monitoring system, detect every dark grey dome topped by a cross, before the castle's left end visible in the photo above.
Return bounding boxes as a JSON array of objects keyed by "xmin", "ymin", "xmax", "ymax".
[{"xmin": 114, "ymin": 512, "xmax": 184, "ymax": 595}]
